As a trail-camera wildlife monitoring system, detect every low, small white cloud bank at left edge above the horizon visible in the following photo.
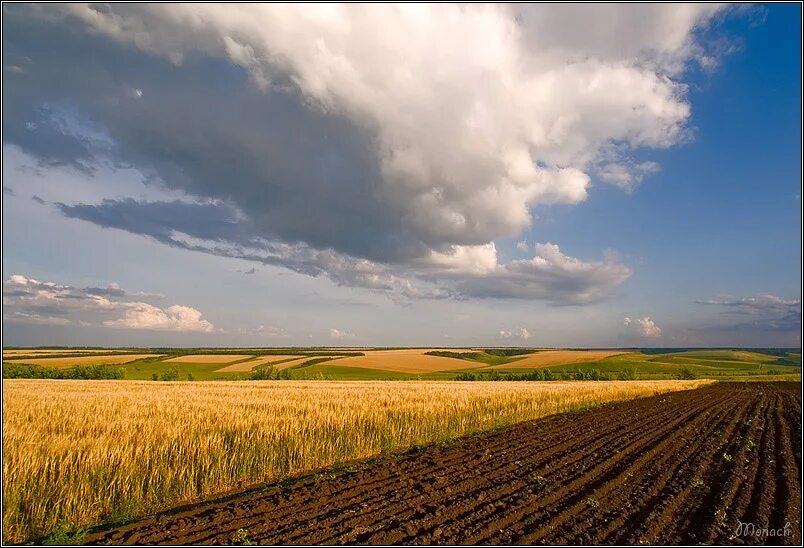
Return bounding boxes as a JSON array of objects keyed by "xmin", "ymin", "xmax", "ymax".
[{"xmin": 3, "ymin": 274, "xmax": 215, "ymax": 332}]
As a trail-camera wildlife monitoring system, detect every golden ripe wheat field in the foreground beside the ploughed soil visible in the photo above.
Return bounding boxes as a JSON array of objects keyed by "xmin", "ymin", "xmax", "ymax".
[{"xmin": 3, "ymin": 379, "xmax": 707, "ymax": 543}]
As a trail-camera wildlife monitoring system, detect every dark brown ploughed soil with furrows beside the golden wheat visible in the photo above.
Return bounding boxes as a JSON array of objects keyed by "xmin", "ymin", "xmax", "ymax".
[{"xmin": 87, "ymin": 383, "xmax": 802, "ymax": 544}]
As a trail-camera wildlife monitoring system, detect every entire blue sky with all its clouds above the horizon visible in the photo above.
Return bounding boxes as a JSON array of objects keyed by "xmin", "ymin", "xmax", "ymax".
[{"xmin": 2, "ymin": 4, "xmax": 802, "ymax": 347}]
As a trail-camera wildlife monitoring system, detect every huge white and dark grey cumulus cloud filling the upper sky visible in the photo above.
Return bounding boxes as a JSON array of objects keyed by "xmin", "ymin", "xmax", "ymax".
[{"xmin": 3, "ymin": 4, "xmax": 732, "ymax": 302}]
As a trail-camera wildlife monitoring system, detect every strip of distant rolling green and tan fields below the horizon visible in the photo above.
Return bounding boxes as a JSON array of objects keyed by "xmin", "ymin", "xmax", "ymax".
[{"xmin": 5, "ymin": 347, "xmax": 801, "ymax": 380}]
